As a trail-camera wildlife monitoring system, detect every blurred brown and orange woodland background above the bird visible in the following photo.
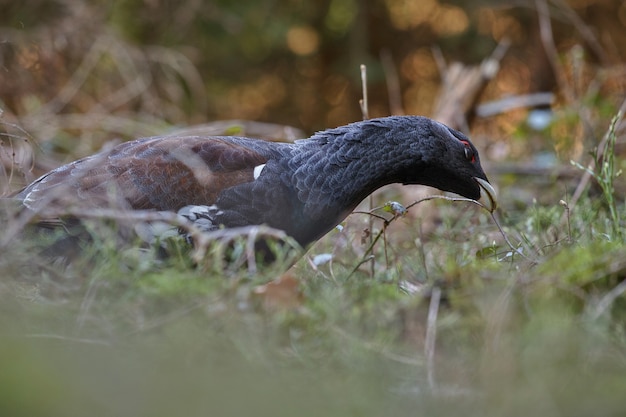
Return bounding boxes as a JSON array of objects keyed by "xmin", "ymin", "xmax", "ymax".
[{"xmin": 0, "ymin": 0, "xmax": 626, "ymax": 192}]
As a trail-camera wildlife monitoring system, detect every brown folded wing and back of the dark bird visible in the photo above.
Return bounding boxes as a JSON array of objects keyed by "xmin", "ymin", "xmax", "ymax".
[{"xmin": 16, "ymin": 137, "xmax": 271, "ymax": 211}]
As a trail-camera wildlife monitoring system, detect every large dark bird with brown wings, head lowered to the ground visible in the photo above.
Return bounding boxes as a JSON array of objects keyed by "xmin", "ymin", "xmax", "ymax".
[{"xmin": 12, "ymin": 116, "xmax": 497, "ymax": 255}]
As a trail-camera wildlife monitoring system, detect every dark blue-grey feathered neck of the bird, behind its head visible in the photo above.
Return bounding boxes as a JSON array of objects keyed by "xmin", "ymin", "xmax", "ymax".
[{"xmin": 290, "ymin": 118, "xmax": 431, "ymax": 219}]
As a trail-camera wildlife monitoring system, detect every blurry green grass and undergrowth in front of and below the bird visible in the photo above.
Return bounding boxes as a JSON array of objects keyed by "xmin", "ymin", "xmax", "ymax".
[{"xmin": 0, "ymin": 175, "xmax": 626, "ymax": 416}]
